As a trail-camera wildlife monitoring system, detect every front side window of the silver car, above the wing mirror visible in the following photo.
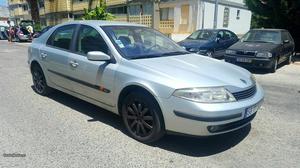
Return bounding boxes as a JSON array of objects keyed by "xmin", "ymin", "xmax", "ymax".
[{"xmin": 76, "ymin": 25, "xmax": 108, "ymax": 54}]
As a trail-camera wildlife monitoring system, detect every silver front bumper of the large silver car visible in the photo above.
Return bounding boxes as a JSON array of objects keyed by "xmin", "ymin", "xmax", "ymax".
[{"xmin": 160, "ymin": 84, "xmax": 264, "ymax": 136}]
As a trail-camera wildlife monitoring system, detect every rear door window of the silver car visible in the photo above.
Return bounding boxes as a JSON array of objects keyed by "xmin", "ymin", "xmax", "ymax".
[{"xmin": 47, "ymin": 25, "xmax": 75, "ymax": 50}]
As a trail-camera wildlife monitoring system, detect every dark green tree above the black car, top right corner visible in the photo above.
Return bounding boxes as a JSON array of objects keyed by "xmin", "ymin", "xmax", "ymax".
[{"xmin": 245, "ymin": 0, "xmax": 300, "ymax": 51}]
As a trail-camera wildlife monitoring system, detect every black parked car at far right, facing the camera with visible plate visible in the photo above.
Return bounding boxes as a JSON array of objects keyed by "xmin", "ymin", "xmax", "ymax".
[{"xmin": 225, "ymin": 29, "xmax": 295, "ymax": 72}]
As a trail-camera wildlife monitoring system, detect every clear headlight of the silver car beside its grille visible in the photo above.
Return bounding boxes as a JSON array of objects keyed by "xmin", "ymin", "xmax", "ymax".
[{"xmin": 173, "ymin": 87, "xmax": 236, "ymax": 103}]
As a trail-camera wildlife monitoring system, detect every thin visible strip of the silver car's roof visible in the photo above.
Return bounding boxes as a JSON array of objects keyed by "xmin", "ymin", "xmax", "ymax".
[{"xmin": 57, "ymin": 20, "xmax": 146, "ymax": 27}]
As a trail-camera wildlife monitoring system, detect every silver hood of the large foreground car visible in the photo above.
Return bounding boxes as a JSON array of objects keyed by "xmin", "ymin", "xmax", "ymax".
[{"xmin": 131, "ymin": 54, "xmax": 253, "ymax": 90}]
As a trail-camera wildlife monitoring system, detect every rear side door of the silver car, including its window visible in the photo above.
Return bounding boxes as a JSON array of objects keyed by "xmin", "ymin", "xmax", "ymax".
[{"xmin": 40, "ymin": 25, "xmax": 76, "ymax": 90}]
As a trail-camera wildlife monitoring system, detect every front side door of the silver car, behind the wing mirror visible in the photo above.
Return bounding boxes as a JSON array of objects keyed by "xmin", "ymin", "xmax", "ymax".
[{"xmin": 69, "ymin": 25, "xmax": 117, "ymax": 106}]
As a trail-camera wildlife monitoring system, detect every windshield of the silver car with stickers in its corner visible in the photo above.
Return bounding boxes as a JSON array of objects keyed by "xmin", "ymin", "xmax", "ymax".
[{"xmin": 102, "ymin": 26, "xmax": 189, "ymax": 59}]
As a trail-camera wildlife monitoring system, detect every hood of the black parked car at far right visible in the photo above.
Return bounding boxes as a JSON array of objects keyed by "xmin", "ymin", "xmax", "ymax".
[{"xmin": 229, "ymin": 42, "xmax": 278, "ymax": 52}]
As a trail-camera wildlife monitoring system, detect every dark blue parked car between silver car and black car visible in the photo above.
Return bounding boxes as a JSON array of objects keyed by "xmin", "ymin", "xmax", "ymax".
[{"xmin": 178, "ymin": 29, "xmax": 238, "ymax": 58}]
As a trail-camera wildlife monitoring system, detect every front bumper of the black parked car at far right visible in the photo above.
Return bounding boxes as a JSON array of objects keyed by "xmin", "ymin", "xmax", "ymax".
[{"xmin": 225, "ymin": 55, "xmax": 274, "ymax": 69}]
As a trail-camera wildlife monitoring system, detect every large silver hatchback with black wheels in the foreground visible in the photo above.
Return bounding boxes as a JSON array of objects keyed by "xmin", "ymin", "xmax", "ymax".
[{"xmin": 28, "ymin": 21, "xmax": 264, "ymax": 143}]
